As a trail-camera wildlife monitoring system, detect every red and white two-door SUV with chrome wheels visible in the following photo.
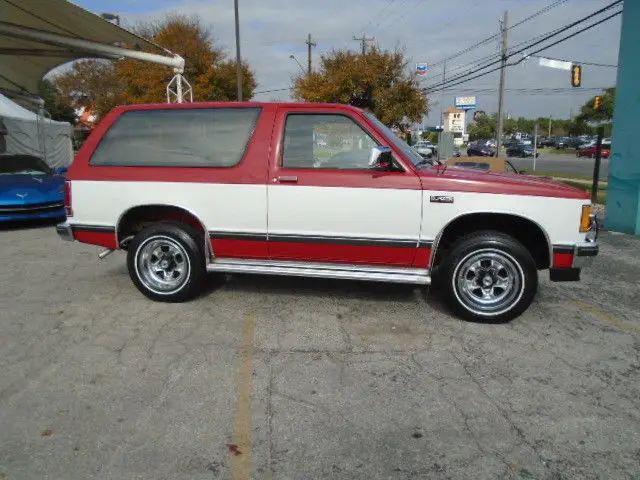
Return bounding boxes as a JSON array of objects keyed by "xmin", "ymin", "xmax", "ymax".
[{"xmin": 57, "ymin": 102, "xmax": 598, "ymax": 322}]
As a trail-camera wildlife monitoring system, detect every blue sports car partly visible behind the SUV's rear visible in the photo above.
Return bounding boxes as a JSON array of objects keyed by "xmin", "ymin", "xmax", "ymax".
[{"xmin": 0, "ymin": 155, "xmax": 66, "ymax": 222}]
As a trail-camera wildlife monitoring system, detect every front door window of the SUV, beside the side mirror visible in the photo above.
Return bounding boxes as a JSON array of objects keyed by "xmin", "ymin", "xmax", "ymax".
[{"xmin": 282, "ymin": 114, "xmax": 378, "ymax": 170}]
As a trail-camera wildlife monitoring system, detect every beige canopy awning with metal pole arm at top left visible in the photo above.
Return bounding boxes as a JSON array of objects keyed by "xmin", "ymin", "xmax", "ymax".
[{"xmin": 0, "ymin": 0, "xmax": 184, "ymax": 95}]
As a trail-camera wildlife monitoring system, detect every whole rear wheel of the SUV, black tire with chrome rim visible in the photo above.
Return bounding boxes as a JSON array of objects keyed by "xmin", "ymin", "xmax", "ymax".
[{"xmin": 127, "ymin": 222, "xmax": 206, "ymax": 303}]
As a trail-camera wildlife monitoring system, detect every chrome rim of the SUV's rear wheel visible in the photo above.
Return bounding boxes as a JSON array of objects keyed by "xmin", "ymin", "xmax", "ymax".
[{"xmin": 136, "ymin": 236, "xmax": 191, "ymax": 295}]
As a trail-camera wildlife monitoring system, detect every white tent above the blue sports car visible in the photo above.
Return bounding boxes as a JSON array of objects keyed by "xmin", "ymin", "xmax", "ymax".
[{"xmin": 0, "ymin": 94, "xmax": 73, "ymax": 168}]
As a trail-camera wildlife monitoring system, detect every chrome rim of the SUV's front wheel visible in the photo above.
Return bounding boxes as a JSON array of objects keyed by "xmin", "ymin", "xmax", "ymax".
[{"xmin": 453, "ymin": 248, "xmax": 524, "ymax": 316}]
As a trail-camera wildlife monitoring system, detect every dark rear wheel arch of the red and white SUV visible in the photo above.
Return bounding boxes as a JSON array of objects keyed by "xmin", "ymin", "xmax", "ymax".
[{"xmin": 115, "ymin": 203, "xmax": 213, "ymax": 259}]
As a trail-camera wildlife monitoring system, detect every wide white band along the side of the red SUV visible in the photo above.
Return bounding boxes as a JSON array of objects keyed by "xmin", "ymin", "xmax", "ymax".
[{"xmin": 70, "ymin": 181, "xmax": 589, "ymax": 248}]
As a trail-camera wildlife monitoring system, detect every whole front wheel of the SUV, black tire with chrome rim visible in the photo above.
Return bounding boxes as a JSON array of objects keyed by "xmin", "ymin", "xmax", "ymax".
[{"xmin": 440, "ymin": 230, "xmax": 538, "ymax": 323}]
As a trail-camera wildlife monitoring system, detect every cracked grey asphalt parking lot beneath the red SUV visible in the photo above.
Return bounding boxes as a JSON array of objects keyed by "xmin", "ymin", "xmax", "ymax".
[{"xmin": 0, "ymin": 223, "xmax": 640, "ymax": 480}]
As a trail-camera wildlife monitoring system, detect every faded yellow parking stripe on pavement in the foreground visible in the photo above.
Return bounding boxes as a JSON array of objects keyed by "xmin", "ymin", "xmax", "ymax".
[{"xmin": 229, "ymin": 312, "xmax": 255, "ymax": 480}]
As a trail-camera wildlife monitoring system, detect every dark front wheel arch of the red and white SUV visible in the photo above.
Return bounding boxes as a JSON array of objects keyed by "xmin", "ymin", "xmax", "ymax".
[{"xmin": 430, "ymin": 211, "xmax": 553, "ymax": 270}]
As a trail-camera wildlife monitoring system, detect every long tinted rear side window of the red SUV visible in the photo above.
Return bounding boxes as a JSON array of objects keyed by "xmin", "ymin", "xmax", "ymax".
[{"xmin": 90, "ymin": 108, "xmax": 260, "ymax": 167}]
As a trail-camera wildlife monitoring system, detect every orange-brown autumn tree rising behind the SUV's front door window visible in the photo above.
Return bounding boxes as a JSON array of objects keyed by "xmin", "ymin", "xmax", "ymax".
[{"xmin": 293, "ymin": 47, "xmax": 428, "ymax": 125}]
